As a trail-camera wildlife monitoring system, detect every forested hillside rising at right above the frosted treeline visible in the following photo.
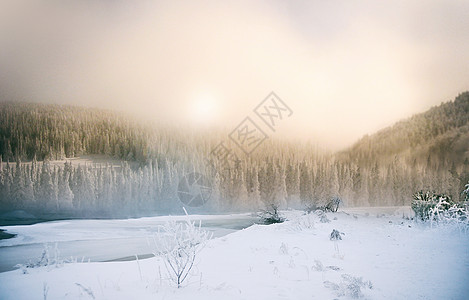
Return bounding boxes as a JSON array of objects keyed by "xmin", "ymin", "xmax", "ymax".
[{"xmin": 341, "ymin": 92, "xmax": 469, "ymax": 164}]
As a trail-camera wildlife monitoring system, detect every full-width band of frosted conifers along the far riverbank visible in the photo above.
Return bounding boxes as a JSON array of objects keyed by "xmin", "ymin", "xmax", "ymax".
[{"xmin": 0, "ymin": 152, "xmax": 469, "ymax": 217}]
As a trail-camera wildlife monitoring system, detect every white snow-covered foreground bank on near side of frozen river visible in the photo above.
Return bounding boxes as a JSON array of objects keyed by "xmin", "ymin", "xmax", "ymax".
[{"xmin": 0, "ymin": 208, "xmax": 469, "ymax": 300}]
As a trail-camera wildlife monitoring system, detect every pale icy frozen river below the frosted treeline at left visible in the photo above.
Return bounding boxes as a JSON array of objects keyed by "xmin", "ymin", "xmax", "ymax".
[{"xmin": 0, "ymin": 214, "xmax": 258, "ymax": 272}]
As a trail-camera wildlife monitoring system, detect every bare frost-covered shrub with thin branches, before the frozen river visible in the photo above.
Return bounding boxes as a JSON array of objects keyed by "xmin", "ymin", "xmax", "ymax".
[{"xmin": 155, "ymin": 220, "xmax": 212, "ymax": 288}]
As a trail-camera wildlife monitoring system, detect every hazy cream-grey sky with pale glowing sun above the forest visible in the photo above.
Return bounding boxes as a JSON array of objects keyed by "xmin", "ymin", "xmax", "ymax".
[{"xmin": 0, "ymin": 0, "xmax": 469, "ymax": 148}]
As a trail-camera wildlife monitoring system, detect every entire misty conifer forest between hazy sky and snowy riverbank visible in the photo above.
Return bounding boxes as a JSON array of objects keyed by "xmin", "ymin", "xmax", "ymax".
[{"xmin": 0, "ymin": 92, "xmax": 469, "ymax": 216}]
